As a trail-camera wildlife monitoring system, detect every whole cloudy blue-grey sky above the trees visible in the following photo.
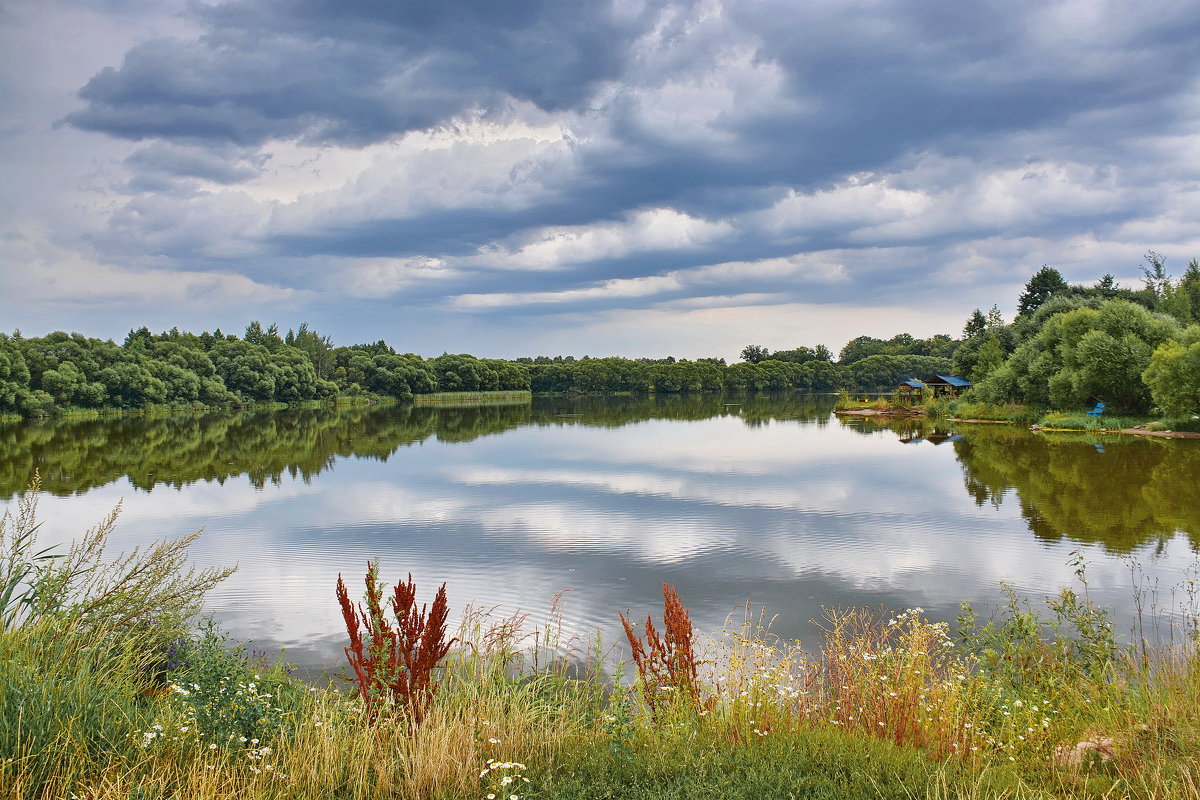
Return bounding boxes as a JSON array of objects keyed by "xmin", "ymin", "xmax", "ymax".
[{"xmin": 0, "ymin": 0, "xmax": 1200, "ymax": 361}]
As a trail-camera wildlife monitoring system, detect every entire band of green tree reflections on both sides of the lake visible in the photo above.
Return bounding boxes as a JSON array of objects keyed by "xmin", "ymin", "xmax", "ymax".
[{"xmin": 7, "ymin": 393, "xmax": 1200, "ymax": 554}]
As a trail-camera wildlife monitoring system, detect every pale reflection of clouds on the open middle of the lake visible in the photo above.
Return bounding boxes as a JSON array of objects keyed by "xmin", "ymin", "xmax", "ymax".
[{"xmin": 23, "ymin": 417, "xmax": 1195, "ymax": 676}]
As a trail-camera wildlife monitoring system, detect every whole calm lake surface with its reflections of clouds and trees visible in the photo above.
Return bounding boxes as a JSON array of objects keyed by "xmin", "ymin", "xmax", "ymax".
[{"xmin": 0, "ymin": 396, "xmax": 1200, "ymax": 673}]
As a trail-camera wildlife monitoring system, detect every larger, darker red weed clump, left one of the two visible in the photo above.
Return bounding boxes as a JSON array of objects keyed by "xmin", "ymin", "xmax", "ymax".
[{"xmin": 337, "ymin": 561, "xmax": 457, "ymax": 724}]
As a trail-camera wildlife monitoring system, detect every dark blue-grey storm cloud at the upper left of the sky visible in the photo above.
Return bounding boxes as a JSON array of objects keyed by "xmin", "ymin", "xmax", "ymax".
[{"xmin": 67, "ymin": 0, "xmax": 643, "ymax": 146}]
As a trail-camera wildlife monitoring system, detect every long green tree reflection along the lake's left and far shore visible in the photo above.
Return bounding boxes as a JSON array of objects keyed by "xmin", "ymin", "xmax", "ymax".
[{"xmin": 0, "ymin": 395, "xmax": 832, "ymax": 499}]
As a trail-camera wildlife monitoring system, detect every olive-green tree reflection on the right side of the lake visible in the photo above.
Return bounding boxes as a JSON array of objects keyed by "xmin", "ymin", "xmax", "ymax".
[{"xmin": 954, "ymin": 428, "xmax": 1200, "ymax": 553}]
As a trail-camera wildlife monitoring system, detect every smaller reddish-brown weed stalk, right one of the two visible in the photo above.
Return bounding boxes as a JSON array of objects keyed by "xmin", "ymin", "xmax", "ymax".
[{"xmin": 620, "ymin": 583, "xmax": 700, "ymax": 712}]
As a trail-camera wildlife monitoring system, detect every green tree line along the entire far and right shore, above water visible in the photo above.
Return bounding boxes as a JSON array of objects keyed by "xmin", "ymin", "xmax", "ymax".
[{"xmin": 0, "ymin": 253, "xmax": 1200, "ymax": 417}]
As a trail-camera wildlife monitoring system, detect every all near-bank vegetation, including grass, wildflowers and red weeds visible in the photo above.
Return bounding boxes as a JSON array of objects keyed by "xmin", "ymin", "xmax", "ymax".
[{"xmin": 0, "ymin": 484, "xmax": 1200, "ymax": 799}]
